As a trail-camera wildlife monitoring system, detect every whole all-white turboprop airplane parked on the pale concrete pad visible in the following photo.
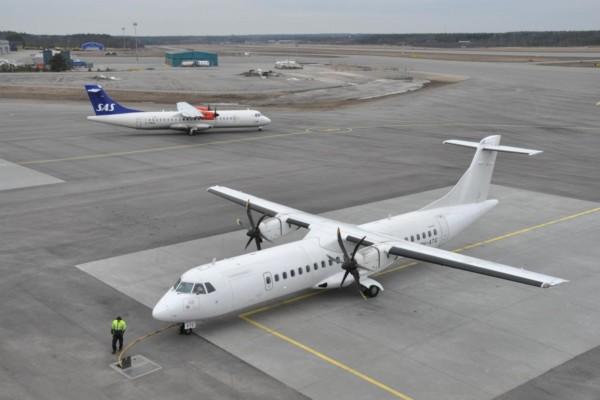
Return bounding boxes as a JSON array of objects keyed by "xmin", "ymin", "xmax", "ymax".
[{"xmin": 152, "ymin": 136, "xmax": 566, "ymax": 333}]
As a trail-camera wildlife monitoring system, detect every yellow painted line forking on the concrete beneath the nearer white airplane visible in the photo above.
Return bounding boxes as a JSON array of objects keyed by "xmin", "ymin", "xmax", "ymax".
[{"xmin": 239, "ymin": 207, "xmax": 600, "ymax": 400}]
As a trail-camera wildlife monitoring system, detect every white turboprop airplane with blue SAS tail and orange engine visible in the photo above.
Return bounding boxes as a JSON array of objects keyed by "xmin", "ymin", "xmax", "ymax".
[{"xmin": 85, "ymin": 85, "xmax": 271, "ymax": 135}]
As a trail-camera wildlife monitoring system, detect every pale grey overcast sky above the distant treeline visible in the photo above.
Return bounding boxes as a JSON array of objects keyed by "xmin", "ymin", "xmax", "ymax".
[{"xmin": 0, "ymin": 0, "xmax": 600, "ymax": 36}]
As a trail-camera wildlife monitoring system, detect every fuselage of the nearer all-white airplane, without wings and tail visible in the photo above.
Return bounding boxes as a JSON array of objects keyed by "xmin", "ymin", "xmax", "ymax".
[{"xmin": 153, "ymin": 200, "xmax": 497, "ymax": 322}]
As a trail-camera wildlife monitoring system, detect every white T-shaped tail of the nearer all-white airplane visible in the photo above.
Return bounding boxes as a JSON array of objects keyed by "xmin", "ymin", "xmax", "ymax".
[{"xmin": 424, "ymin": 135, "xmax": 541, "ymax": 209}]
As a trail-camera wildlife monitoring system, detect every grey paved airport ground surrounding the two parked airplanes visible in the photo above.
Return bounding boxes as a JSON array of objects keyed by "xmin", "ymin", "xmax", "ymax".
[{"xmin": 0, "ymin": 51, "xmax": 600, "ymax": 399}]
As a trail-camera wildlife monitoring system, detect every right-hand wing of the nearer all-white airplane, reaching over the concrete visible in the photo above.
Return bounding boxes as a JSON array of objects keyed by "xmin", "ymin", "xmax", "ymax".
[{"xmin": 346, "ymin": 236, "xmax": 568, "ymax": 288}]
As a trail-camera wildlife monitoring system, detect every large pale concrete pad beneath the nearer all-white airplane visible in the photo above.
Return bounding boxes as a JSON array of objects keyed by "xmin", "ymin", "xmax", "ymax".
[{"xmin": 77, "ymin": 186, "xmax": 600, "ymax": 399}]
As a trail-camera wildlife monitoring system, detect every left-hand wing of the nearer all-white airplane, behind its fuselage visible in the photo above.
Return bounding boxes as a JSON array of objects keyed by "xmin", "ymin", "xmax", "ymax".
[{"xmin": 207, "ymin": 186, "xmax": 328, "ymax": 228}]
